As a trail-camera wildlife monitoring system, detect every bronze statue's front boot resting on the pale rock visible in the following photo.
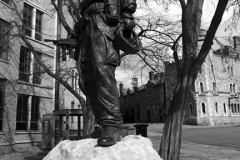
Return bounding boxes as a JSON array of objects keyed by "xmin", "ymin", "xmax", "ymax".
[{"xmin": 97, "ymin": 125, "xmax": 120, "ymax": 147}]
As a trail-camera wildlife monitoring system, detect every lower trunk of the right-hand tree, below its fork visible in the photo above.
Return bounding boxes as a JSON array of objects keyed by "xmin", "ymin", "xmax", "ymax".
[{"xmin": 159, "ymin": 79, "xmax": 191, "ymax": 160}]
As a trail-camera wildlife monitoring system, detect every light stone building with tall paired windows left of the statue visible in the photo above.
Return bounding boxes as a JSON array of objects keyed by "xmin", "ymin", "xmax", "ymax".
[{"xmin": 0, "ymin": 0, "xmax": 80, "ymax": 155}]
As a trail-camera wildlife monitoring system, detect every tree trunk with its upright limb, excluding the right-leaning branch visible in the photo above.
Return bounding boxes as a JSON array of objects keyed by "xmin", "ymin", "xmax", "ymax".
[{"xmin": 159, "ymin": 0, "xmax": 204, "ymax": 160}]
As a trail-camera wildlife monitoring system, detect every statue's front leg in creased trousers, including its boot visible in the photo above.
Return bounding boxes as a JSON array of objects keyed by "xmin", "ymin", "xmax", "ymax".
[{"xmin": 90, "ymin": 17, "xmax": 123, "ymax": 146}]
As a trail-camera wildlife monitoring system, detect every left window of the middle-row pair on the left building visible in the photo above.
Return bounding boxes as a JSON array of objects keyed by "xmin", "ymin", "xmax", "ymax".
[{"xmin": 19, "ymin": 46, "xmax": 30, "ymax": 82}]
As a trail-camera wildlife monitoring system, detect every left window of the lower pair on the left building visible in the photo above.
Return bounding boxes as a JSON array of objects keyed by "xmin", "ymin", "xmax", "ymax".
[{"xmin": 16, "ymin": 94, "xmax": 28, "ymax": 131}]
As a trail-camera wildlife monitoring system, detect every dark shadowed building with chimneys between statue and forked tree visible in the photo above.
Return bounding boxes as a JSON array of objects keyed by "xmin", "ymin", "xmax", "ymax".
[{"xmin": 119, "ymin": 72, "xmax": 166, "ymax": 123}]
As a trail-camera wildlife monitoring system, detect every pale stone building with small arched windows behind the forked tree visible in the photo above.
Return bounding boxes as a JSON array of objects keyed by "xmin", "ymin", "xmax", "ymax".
[{"xmin": 165, "ymin": 37, "xmax": 240, "ymax": 125}]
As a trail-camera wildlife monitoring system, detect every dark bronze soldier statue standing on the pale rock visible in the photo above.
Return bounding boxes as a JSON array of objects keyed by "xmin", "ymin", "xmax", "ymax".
[{"xmin": 46, "ymin": 0, "xmax": 141, "ymax": 146}]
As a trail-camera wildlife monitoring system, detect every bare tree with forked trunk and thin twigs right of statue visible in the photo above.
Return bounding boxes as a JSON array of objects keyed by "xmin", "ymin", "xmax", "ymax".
[{"xmin": 122, "ymin": 0, "xmax": 239, "ymax": 160}]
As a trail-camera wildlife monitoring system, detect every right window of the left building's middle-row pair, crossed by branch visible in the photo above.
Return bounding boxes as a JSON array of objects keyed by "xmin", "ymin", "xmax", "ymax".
[{"xmin": 33, "ymin": 52, "xmax": 42, "ymax": 84}]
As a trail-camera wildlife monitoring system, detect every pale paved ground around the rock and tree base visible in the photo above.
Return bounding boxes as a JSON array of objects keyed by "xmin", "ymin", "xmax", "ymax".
[{"xmin": 0, "ymin": 124, "xmax": 240, "ymax": 160}]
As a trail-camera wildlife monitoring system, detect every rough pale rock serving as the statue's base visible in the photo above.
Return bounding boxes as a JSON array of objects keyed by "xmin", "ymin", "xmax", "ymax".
[{"xmin": 43, "ymin": 135, "xmax": 162, "ymax": 160}]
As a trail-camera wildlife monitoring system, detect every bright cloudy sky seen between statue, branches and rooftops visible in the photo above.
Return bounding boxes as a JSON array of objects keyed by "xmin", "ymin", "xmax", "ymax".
[{"xmin": 116, "ymin": 0, "xmax": 239, "ymax": 88}]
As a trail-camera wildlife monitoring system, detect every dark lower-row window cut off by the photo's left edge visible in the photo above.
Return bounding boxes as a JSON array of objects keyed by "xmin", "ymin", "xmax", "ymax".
[{"xmin": 0, "ymin": 79, "xmax": 5, "ymax": 131}]
